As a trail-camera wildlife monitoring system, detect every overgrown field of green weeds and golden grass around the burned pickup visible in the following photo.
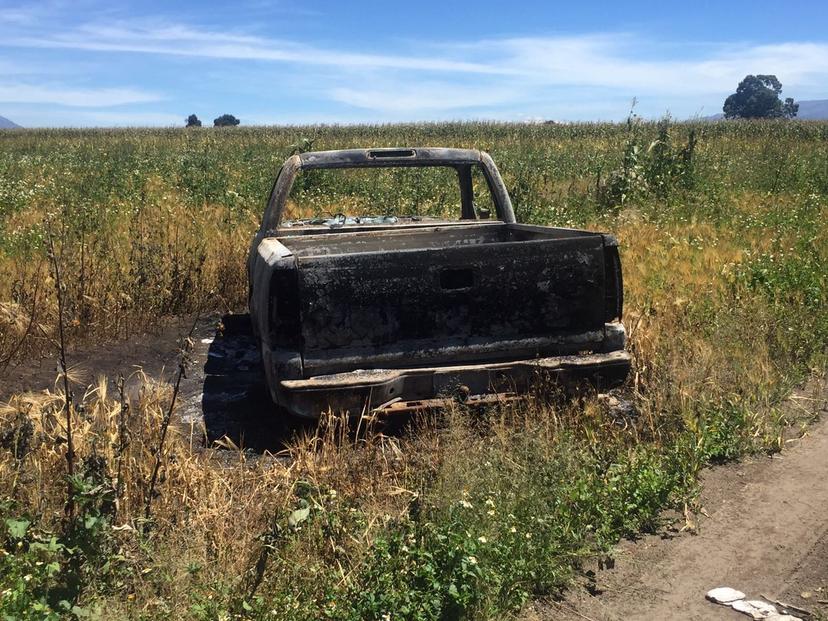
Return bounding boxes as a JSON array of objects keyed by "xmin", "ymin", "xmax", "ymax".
[{"xmin": 0, "ymin": 118, "xmax": 828, "ymax": 619}]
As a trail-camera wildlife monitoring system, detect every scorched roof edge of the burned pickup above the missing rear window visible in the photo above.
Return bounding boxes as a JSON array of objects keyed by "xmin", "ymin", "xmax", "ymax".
[{"xmin": 298, "ymin": 147, "xmax": 481, "ymax": 170}]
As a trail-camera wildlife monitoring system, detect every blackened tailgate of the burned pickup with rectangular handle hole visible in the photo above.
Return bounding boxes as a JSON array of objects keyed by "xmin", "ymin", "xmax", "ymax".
[{"xmin": 298, "ymin": 234, "xmax": 606, "ymax": 376}]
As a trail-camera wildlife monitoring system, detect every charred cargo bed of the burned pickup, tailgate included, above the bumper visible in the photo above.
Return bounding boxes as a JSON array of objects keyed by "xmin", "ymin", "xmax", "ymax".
[{"xmin": 265, "ymin": 222, "xmax": 617, "ymax": 378}]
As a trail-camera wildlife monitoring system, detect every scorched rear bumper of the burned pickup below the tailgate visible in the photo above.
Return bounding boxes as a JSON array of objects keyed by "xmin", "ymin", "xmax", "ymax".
[{"xmin": 278, "ymin": 351, "xmax": 630, "ymax": 418}]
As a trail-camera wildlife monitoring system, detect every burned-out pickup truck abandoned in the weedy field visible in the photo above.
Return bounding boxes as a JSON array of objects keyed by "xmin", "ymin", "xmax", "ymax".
[{"xmin": 248, "ymin": 148, "xmax": 630, "ymax": 417}]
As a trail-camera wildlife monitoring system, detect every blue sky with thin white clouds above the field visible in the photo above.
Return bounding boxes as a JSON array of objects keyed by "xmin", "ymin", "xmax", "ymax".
[{"xmin": 0, "ymin": 0, "xmax": 828, "ymax": 127}]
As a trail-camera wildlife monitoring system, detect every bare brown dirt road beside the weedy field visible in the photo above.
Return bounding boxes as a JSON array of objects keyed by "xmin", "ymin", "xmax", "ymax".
[{"xmin": 525, "ymin": 382, "xmax": 828, "ymax": 621}]
